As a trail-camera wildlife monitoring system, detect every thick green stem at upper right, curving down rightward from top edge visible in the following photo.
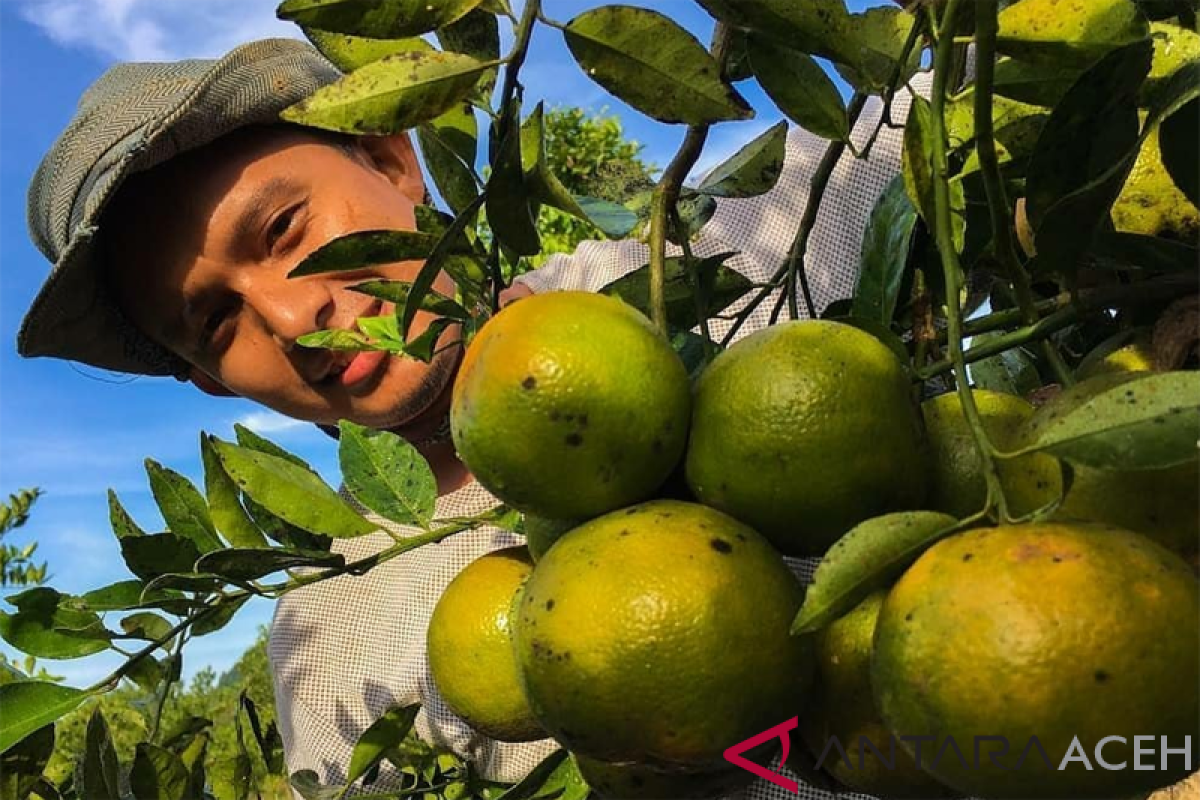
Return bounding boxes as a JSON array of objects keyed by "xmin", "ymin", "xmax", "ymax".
[{"xmin": 974, "ymin": 0, "xmax": 1075, "ymax": 386}]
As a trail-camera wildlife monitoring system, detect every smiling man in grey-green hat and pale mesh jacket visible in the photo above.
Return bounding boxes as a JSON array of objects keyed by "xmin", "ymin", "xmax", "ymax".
[{"xmin": 18, "ymin": 40, "xmax": 907, "ymax": 799}]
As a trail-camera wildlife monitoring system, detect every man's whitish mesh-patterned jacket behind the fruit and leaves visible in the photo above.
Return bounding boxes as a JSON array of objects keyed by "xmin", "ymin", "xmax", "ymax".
[{"xmin": 270, "ymin": 79, "xmax": 919, "ymax": 800}]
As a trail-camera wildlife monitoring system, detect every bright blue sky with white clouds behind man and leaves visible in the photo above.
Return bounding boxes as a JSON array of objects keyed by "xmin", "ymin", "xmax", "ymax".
[{"xmin": 0, "ymin": 0, "xmax": 883, "ymax": 685}]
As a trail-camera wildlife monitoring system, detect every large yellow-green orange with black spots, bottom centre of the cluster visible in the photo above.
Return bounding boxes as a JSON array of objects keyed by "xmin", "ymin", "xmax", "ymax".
[{"xmin": 515, "ymin": 500, "xmax": 812, "ymax": 770}]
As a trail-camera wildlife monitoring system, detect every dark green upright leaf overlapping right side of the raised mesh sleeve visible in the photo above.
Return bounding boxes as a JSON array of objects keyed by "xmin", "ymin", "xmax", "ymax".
[{"xmin": 850, "ymin": 175, "xmax": 917, "ymax": 325}]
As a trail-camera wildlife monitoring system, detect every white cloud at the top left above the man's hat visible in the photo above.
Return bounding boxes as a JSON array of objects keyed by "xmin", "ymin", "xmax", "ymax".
[{"xmin": 17, "ymin": 0, "xmax": 299, "ymax": 61}]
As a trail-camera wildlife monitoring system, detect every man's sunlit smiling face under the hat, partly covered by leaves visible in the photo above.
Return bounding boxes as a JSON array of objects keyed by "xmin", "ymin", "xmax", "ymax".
[{"xmin": 106, "ymin": 128, "xmax": 460, "ymax": 428}]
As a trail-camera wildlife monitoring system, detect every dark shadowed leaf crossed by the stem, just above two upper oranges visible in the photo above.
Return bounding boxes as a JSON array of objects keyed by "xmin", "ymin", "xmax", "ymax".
[{"xmin": 600, "ymin": 253, "xmax": 754, "ymax": 330}]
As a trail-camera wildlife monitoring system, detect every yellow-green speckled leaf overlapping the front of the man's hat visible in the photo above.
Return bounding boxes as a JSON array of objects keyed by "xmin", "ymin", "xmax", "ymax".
[{"xmin": 280, "ymin": 52, "xmax": 492, "ymax": 134}]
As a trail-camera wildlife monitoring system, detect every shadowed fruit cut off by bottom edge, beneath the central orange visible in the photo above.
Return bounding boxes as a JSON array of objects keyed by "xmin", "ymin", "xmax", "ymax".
[{"xmin": 575, "ymin": 754, "xmax": 754, "ymax": 800}]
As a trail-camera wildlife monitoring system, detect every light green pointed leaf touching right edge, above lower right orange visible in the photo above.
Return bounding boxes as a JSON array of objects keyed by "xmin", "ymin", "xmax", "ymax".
[{"xmin": 1030, "ymin": 372, "xmax": 1200, "ymax": 469}]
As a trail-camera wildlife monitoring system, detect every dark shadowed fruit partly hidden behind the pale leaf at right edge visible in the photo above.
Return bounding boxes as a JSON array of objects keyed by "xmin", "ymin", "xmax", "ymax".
[{"xmin": 1028, "ymin": 372, "xmax": 1200, "ymax": 569}]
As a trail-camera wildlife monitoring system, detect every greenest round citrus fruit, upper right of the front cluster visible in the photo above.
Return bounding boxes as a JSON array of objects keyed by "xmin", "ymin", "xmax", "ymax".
[{"xmin": 686, "ymin": 320, "xmax": 925, "ymax": 555}]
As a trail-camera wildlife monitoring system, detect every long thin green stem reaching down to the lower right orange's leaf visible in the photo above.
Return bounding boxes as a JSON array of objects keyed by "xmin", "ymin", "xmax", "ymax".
[{"xmin": 926, "ymin": 0, "xmax": 1008, "ymax": 519}]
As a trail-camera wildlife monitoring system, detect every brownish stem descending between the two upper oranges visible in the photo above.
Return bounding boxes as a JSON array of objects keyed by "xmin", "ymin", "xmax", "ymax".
[{"xmin": 649, "ymin": 23, "xmax": 733, "ymax": 336}]
